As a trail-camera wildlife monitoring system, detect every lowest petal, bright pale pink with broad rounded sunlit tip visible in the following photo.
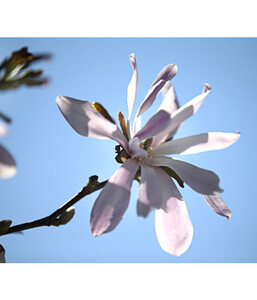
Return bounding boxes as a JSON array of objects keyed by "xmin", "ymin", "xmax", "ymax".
[{"xmin": 155, "ymin": 174, "xmax": 193, "ymax": 256}]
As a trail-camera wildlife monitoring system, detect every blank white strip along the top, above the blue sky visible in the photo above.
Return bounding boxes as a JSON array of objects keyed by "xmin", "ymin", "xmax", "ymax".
[{"xmin": 0, "ymin": 0, "xmax": 257, "ymax": 37}]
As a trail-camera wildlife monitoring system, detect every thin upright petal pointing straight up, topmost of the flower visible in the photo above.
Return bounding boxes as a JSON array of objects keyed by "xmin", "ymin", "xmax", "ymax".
[{"xmin": 127, "ymin": 53, "xmax": 138, "ymax": 120}]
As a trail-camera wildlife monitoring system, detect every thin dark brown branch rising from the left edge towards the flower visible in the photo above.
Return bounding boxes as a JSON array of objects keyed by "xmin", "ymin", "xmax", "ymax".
[{"xmin": 3, "ymin": 176, "xmax": 108, "ymax": 235}]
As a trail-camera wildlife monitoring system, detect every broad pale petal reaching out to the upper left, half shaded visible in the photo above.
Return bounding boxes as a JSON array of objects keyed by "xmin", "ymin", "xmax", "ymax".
[{"xmin": 56, "ymin": 96, "xmax": 128, "ymax": 150}]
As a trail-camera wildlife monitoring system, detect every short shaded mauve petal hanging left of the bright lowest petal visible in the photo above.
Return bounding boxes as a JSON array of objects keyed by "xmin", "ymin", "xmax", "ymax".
[{"xmin": 137, "ymin": 163, "xmax": 165, "ymax": 217}]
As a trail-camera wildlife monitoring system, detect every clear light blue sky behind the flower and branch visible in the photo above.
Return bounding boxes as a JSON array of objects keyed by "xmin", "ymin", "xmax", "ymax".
[{"xmin": 0, "ymin": 38, "xmax": 254, "ymax": 263}]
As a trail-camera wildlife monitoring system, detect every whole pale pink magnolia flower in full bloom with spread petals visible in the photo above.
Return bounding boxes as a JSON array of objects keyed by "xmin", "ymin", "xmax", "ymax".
[{"xmin": 56, "ymin": 54, "xmax": 240, "ymax": 256}]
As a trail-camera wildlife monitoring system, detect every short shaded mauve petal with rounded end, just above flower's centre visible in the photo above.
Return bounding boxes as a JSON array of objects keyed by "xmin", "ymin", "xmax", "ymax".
[{"xmin": 135, "ymin": 110, "xmax": 170, "ymax": 142}]
